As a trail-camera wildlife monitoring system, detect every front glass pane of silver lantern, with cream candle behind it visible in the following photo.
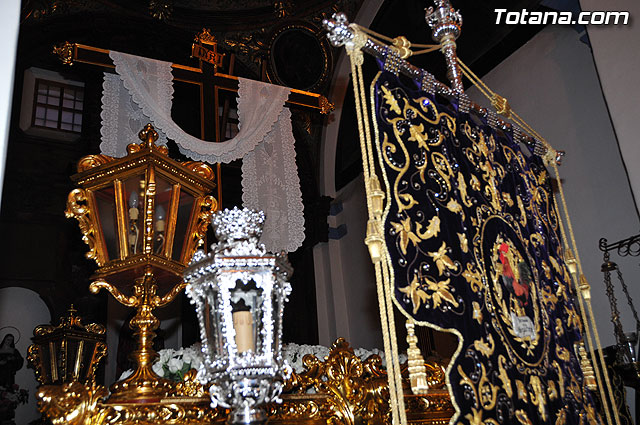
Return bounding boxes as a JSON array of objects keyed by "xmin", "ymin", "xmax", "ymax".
[{"xmin": 230, "ymin": 279, "xmax": 263, "ymax": 353}]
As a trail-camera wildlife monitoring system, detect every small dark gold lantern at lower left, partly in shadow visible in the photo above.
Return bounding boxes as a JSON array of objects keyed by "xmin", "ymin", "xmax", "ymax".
[{"xmin": 27, "ymin": 305, "xmax": 107, "ymax": 385}]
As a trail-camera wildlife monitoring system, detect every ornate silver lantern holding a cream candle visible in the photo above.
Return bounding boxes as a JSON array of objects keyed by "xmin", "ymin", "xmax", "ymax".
[{"xmin": 184, "ymin": 208, "xmax": 292, "ymax": 424}]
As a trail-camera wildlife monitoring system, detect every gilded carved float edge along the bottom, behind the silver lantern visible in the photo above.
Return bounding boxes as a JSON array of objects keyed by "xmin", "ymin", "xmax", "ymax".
[{"xmin": 38, "ymin": 338, "xmax": 454, "ymax": 425}]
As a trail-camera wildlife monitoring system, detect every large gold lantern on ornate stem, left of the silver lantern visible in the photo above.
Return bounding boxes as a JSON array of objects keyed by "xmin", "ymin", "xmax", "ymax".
[{"xmin": 66, "ymin": 124, "xmax": 217, "ymax": 401}]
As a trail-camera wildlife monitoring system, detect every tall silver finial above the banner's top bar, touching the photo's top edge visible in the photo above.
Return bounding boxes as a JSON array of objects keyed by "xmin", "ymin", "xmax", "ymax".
[{"xmin": 425, "ymin": 0, "xmax": 464, "ymax": 93}]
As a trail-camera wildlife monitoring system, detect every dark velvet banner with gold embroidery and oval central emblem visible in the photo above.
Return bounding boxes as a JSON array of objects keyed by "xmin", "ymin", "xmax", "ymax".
[{"xmin": 372, "ymin": 72, "xmax": 600, "ymax": 425}]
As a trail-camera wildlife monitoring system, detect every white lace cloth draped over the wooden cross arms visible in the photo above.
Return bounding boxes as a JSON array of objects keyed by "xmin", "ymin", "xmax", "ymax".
[{"xmin": 100, "ymin": 51, "xmax": 304, "ymax": 252}]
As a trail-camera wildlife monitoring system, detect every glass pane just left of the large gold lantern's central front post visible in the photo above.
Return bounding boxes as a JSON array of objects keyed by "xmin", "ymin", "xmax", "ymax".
[{"xmin": 124, "ymin": 174, "xmax": 145, "ymax": 255}]
